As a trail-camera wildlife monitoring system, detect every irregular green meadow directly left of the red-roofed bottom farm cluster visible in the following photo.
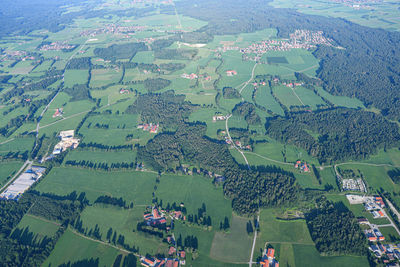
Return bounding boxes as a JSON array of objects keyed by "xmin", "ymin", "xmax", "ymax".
[{"xmin": 81, "ymin": 204, "xmax": 168, "ymax": 255}]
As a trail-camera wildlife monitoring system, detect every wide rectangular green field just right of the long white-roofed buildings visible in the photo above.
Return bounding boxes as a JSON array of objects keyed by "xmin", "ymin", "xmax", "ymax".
[{"xmin": 36, "ymin": 167, "xmax": 156, "ymax": 205}]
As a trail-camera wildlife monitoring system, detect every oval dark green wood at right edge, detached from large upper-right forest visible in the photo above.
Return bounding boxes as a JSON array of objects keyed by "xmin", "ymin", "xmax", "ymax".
[{"xmin": 265, "ymin": 108, "xmax": 400, "ymax": 163}]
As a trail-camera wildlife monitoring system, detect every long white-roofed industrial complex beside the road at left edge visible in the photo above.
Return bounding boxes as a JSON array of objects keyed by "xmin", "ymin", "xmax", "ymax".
[{"xmin": 0, "ymin": 166, "xmax": 46, "ymax": 200}]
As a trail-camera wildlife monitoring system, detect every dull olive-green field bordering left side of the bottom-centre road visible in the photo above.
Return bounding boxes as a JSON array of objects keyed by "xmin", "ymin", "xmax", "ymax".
[{"xmin": 210, "ymin": 215, "xmax": 253, "ymax": 263}]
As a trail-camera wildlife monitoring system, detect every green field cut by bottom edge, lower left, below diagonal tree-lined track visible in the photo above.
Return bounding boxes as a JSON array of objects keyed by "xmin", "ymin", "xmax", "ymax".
[{"xmin": 42, "ymin": 229, "xmax": 119, "ymax": 266}]
